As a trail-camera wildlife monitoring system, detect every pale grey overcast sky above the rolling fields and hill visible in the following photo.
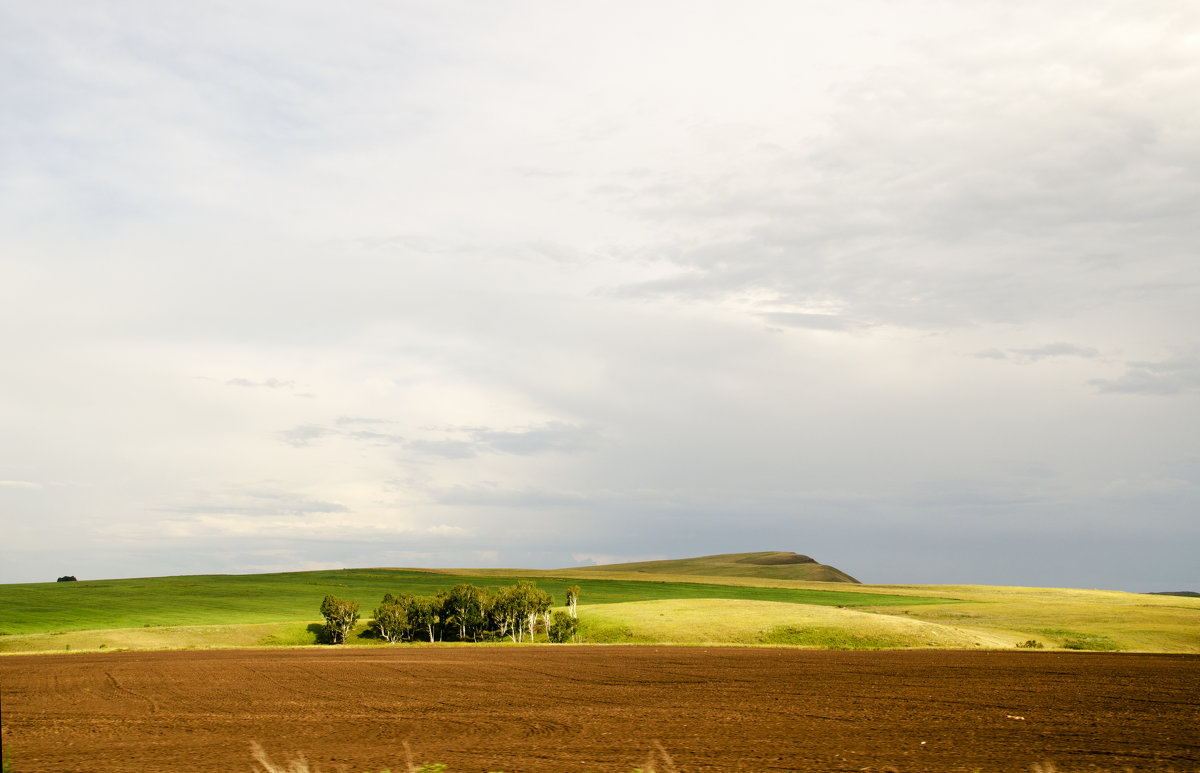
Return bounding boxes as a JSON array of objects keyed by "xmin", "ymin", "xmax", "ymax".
[{"xmin": 0, "ymin": 0, "xmax": 1200, "ymax": 591}]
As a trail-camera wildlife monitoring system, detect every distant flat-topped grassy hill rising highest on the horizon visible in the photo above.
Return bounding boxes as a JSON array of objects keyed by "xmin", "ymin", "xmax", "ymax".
[{"xmin": 571, "ymin": 551, "xmax": 858, "ymax": 583}]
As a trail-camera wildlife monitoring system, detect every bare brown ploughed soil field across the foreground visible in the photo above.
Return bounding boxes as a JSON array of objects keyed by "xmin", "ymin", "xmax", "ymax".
[{"xmin": 0, "ymin": 646, "xmax": 1200, "ymax": 773}]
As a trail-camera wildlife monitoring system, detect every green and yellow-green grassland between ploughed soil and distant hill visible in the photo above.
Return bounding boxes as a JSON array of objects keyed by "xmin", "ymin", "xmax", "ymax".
[{"xmin": 0, "ymin": 559, "xmax": 1200, "ymax": 653}]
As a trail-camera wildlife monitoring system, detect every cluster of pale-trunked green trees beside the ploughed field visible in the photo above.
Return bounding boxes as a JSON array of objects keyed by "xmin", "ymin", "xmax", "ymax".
[{"xmin": 320, "ymin": 580, "xmax": 580, "ymax": 645}]
